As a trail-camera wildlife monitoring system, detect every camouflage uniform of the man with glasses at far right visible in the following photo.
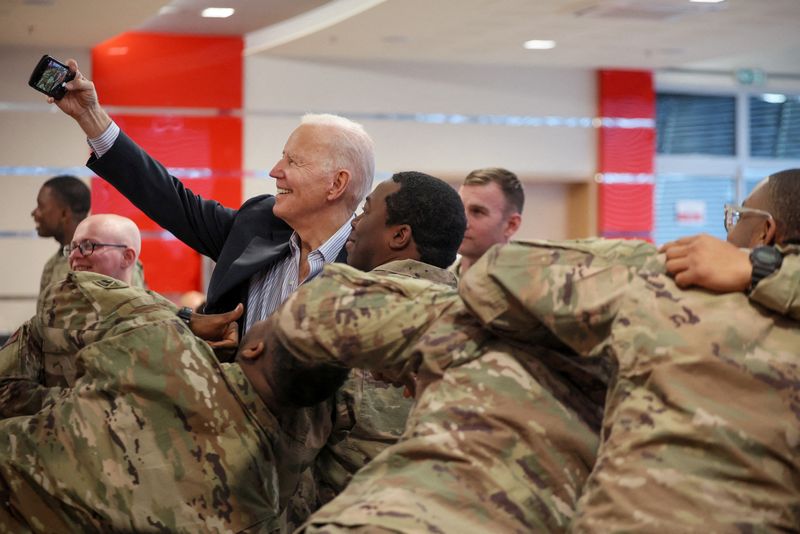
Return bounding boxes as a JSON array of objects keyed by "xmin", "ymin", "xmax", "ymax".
[{"xmin": 460, "ymin": 240, "xmax": 800, "ymax": 532}]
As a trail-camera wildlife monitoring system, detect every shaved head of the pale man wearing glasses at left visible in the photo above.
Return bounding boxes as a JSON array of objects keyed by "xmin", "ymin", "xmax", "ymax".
[{"xmin": 69, "ymin": 214, "xmax": 142, "ymax": 284}]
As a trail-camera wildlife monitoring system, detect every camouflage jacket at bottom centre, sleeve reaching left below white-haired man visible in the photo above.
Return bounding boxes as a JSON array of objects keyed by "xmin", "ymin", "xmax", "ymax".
[{"xmin": 273, "ymin": 265, "xmax": 598, "ymax": 533}]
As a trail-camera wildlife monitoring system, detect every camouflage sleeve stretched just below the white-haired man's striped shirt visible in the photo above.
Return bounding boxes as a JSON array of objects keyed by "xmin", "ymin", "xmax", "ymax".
[{"xmin": 271, "ymin": 265, "xmax": 458, "ymax": 376}]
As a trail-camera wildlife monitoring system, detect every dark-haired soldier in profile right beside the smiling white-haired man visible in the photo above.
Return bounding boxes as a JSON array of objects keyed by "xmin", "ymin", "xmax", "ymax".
[{"xmin": 287, "ymin": 172, "xmax": 466, "ymax": 530}]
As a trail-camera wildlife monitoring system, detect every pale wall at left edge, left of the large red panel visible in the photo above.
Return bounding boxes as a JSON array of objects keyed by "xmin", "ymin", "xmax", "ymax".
[{"xmin": 0, "ymin": 47, "xmax": 91, "ymax": 333}]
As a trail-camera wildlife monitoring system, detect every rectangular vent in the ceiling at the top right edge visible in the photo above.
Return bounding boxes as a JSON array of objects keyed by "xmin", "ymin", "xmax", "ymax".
[{"xmin": 573, "ymin": 0, "xmax": 724, "ymax": 21}]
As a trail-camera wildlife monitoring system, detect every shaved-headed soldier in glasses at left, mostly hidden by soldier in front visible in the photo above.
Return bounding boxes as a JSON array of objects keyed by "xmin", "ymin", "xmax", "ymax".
[{"xmin": 0, "ymin": 215, "xmax": 155, "ymax": 417}]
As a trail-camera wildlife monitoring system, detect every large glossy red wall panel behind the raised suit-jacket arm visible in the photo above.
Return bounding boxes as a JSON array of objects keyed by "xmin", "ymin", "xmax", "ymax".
[{"xmin": 92, "ymin": 32, "xmax": 243, "ymax": 293}]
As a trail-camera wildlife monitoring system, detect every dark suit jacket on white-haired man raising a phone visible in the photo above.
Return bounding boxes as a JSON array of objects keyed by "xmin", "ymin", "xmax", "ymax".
[{"xmin": 88, "ymin": 132, "xmax": 347, "ymax": 324}]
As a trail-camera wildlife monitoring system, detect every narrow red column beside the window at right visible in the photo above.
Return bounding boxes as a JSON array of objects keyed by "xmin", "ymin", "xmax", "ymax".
[{"xmin": 598, "ymin": 70, "xmax": 655, "ymax": 240}]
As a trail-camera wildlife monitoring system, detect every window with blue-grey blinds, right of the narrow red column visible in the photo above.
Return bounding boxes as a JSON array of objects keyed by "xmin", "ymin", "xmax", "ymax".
[{"xmin": 653, "ymin": 87, "xmax": 800, "ymax": 244}]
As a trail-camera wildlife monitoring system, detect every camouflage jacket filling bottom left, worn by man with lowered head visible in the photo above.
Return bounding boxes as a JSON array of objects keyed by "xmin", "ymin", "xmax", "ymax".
[{"xmin": 0, "ymin": 272, "xmax": 278, "ymax": 532}]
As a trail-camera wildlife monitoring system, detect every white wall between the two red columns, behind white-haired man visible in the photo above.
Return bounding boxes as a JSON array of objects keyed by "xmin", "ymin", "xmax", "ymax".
[{"xmin": 244, "ymin": 56, "xmax": 596, "ymax": 243}]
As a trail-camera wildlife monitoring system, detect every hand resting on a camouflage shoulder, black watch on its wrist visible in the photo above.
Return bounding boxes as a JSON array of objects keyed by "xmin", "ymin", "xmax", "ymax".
[{"xmin": 660, "ymin": 234, "xmax": 753, "ymax": 293}]
